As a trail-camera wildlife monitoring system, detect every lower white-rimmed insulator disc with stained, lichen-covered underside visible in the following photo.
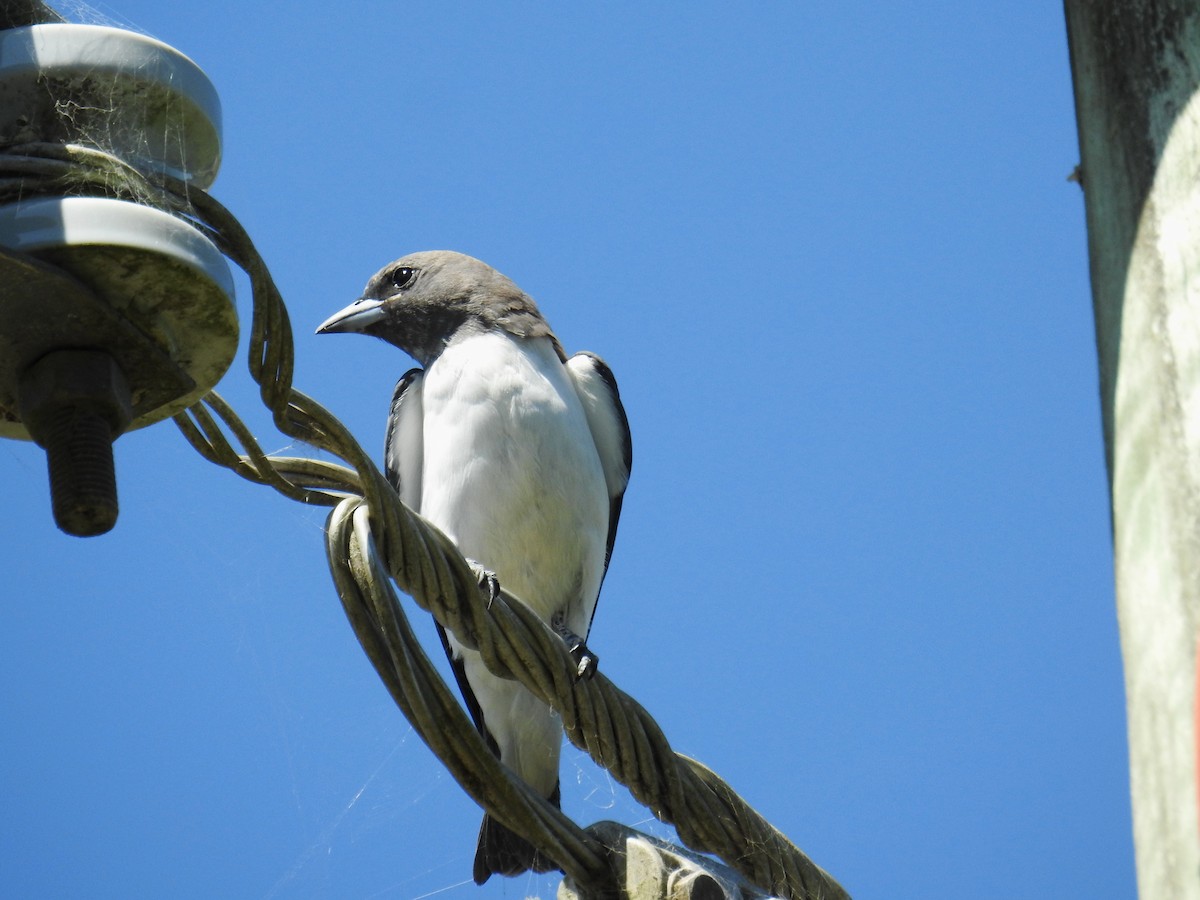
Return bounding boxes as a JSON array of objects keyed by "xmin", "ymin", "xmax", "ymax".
[{"xmin": 0, "ymin": 196, "xmax": 238, "ymax": 438}]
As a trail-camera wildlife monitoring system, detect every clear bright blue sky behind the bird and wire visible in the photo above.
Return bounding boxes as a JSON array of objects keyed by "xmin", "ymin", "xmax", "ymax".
[{"xmin": 0, "ymin": 7, "xmax": 1134, "ymax": 900}]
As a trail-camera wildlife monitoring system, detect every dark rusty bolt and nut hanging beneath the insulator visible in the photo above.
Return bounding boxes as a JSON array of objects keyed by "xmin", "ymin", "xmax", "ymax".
[{"xmin": 18, "ymin": 350, "xmax": 133, "ymax": 538}]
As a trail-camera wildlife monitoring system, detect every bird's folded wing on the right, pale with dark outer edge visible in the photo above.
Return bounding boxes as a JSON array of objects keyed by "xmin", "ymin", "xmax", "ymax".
[{"xmin": 566, "ymin": 352, "xmax": 634, "ymax": 571}]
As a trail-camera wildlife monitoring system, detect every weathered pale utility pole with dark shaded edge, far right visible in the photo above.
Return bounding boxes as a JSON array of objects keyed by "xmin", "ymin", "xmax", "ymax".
[{"xmin": 1066, "ymin": 0, "xmax": 1200, "ymax": 900}]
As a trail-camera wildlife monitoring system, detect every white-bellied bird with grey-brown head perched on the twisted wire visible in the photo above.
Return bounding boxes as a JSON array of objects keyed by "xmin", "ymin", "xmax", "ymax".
[{"xmin": 317, "ymin": 250, "xmax": 632, "ymax": 884}]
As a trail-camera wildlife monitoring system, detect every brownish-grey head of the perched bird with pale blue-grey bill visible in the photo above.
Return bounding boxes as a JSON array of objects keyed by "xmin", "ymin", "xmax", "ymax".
[{"xmin": 317, "ymin": 250, "xmax": 564, "ymax": 366}]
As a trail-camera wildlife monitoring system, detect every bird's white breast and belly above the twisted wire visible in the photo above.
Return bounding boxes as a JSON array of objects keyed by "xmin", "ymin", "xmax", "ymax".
[{"xmin": 420, "ymin": 332, "xmax": 608, "ymax": 634}]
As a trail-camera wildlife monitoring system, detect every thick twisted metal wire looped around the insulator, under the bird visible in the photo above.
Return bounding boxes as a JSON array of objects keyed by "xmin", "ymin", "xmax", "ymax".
[{"xmin": 0, "ymin": 144, "xmax": 848, "ymax": 900}]
